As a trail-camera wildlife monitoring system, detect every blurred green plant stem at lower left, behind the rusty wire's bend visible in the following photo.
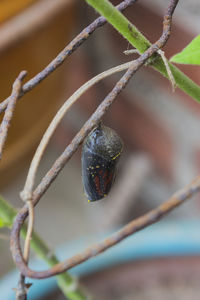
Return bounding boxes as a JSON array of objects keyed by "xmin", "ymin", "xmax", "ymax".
[{"xmin": 0, "ymin": 196, "xmax": 88, "ymax": 300}]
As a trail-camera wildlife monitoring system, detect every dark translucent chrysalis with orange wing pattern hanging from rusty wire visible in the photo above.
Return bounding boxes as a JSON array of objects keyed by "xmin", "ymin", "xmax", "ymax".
[{"xmin": 81, "ymin": 124, "xmax": 123, "ymax": 202}]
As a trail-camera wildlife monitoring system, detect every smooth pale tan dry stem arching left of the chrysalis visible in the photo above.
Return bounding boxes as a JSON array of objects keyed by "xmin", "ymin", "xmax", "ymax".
[{"xmin": 20, "ymin": 61, "xmax": 132, "ymax": 201}]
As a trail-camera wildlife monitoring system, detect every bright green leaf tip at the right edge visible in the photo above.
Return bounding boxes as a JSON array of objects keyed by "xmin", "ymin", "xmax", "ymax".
[{"xmin": 170, "ymin": 35, "xmax": 200, "ymax": 65}]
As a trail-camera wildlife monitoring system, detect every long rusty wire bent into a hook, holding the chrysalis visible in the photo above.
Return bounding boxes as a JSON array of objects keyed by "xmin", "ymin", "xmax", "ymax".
[{"xmin": 11, "ymin": 0, "xmax": 180, "ymax": 278}]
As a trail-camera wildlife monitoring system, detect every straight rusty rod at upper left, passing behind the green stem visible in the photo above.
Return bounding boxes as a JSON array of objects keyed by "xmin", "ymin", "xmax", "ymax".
[{"xmin": 0, "ymin": 0, "xmax": 137, "ymax": 113}]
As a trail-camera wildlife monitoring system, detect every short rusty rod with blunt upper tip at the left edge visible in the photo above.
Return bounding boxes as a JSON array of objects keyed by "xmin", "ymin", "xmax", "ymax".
[{"xmin": 0, "ymin": 71, "xmax": 27, "ymax": 159}]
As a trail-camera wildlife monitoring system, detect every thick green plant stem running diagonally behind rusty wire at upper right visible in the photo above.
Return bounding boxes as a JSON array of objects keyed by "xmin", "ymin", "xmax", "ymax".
[{"xmin": 85, "ymin": 0, "xmax": 200, "ymax": 102}]
